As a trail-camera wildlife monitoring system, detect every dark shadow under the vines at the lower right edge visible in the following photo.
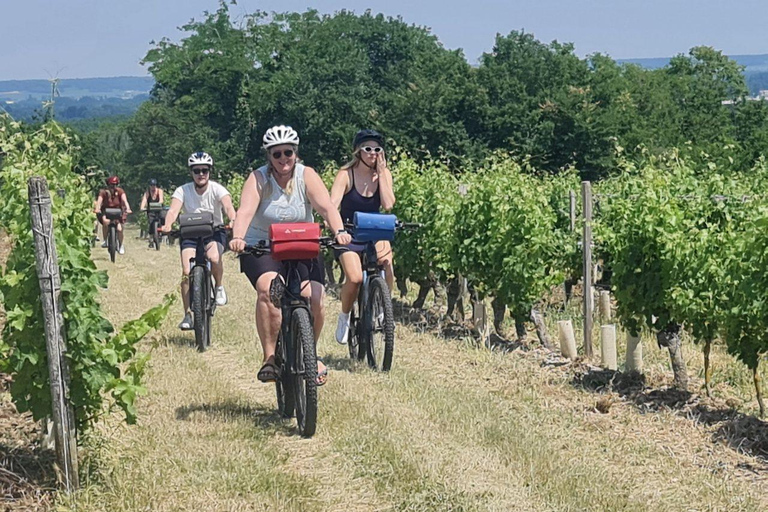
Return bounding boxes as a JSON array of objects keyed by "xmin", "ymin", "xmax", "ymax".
[{"xmin": 571, "ymin": 366, "xmax": 768, "ymax": 466}]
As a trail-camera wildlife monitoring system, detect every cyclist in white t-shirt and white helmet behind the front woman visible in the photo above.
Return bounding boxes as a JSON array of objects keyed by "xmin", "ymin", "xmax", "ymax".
[{"xmin": 161, "ymin": 151, "xmax": 236, "ymax": 330}]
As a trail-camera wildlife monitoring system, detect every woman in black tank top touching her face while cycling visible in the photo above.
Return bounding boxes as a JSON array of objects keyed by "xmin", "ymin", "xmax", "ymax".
[{"xmin": 331, "ymin": 130, "xmax": 395, "ymax": 344}]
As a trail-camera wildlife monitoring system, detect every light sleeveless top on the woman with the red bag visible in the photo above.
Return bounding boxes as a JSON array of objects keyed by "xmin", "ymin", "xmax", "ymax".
[{"xmin": 245, "ymin": 163, "xmax": 314, "ymax": 245}]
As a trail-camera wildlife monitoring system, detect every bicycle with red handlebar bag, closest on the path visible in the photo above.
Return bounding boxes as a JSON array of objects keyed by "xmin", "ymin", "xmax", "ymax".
[{"xmin": 243, "ymin": 224, "xmax": 333, "ymax": 437}]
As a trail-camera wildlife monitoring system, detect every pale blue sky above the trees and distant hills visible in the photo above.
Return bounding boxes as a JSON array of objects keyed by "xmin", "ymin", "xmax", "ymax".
[{"xmin": 0, "ymin": 0, "xmax": 768, "ymax": 80}]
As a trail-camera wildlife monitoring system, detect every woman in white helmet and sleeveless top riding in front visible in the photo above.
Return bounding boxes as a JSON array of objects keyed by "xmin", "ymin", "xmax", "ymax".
[{"xmin": 230, "ymin": 126, "xmax": 352, "ymax": 385}]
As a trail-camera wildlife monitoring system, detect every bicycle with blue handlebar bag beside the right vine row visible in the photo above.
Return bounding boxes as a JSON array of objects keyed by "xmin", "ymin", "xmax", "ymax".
[{"xmin": 346, "ymin": 212, "xmax": 421, "ymax": 372}]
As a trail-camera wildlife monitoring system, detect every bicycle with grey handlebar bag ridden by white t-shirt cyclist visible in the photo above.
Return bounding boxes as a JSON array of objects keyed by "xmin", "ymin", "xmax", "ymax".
[{"xmin": 168, "ymin": 213, "xmax": 225, "ymax": 352}]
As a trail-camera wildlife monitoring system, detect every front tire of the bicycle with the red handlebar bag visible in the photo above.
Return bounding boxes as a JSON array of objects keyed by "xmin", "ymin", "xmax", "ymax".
[{"xmin": 290, "ymin": 308, "xmax": 317, "ymax": 437}]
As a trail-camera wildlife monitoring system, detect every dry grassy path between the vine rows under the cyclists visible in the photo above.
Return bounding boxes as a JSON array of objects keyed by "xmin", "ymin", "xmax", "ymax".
[{"xmin": 62, "ymin": 230, "xmax": 768, "ymax": 511}]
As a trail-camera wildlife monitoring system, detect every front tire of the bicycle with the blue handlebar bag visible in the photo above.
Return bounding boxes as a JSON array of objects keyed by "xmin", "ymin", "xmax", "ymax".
[{"xmin": 366, "ymin": 277, "xmax": 395, "ymax": 372}]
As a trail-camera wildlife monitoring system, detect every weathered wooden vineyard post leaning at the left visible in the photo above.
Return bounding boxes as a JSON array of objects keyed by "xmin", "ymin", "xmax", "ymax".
[{"xmin": 27, "ymin": 177, "xmax": 78, "ymax": 492}]
